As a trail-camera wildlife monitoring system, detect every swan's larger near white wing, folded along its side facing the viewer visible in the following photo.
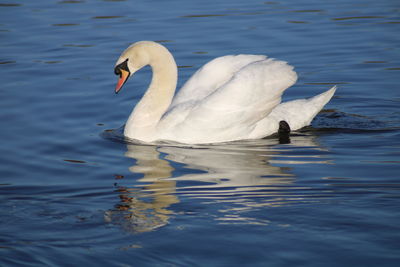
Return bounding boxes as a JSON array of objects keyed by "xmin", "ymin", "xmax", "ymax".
[{"xmin": 166, "ymin": 59, "xmax": 297, "ymax": 142}]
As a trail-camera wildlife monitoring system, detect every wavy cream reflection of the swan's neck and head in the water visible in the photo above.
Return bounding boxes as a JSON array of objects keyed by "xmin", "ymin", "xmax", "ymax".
[{"xmin": 105, "ymin": 145, "xmax": 178, "ymax": 232}]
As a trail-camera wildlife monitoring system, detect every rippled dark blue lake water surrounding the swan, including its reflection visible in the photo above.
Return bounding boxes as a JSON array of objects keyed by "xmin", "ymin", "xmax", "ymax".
[{"xmin": 0, "ymin": 0, "xmax": 400, "ymax": 266}]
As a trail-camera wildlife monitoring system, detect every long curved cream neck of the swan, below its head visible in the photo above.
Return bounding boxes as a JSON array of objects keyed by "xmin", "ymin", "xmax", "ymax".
[{"xmin": 124, "ymin": 47, "xmax": 178, "ymax": 141}]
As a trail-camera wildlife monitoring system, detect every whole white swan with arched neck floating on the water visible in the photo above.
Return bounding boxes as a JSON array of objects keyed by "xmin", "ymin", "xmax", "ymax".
[{"xmin": 114, "ymin": 41, "xmax": 336, "ymax": 144}]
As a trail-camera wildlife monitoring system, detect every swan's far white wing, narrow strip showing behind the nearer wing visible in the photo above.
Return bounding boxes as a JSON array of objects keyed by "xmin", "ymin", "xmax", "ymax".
[{"xmin": 171, "ymin": 55, "xmax": 266, "ymax": 108}]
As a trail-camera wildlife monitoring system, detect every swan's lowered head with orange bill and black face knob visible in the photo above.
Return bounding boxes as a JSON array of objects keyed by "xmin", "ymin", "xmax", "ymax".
[{"xmin": 114, "ymin": 41, "xmax": 153, "ymax": 93}]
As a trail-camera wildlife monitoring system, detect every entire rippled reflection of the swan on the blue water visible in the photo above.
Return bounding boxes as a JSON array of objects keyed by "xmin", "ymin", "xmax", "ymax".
[{"xmin": 106, "ymin": 136, "xmax": 329, "ymax": 232}]
